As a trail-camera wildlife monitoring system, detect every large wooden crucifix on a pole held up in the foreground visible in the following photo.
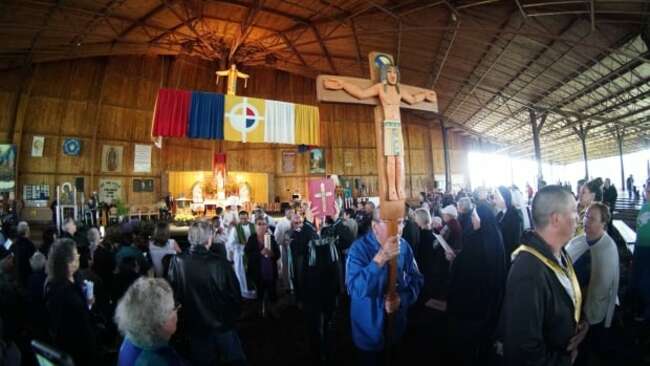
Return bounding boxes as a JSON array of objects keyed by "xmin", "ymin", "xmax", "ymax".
[{"xmin": 316, "ymin": 52, "xmax": 438, "ymax": 316}]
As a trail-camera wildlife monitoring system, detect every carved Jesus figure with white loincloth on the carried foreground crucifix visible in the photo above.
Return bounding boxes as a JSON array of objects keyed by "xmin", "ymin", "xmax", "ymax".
[{"xmin": 323, "ymin": 65, "xmax": 436, "ymax": 201}]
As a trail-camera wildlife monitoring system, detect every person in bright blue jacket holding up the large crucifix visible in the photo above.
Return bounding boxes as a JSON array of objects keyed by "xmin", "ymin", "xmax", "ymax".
[{"xmin": 345, "ymin": 211, "xmax": 424, "ymax": 365}]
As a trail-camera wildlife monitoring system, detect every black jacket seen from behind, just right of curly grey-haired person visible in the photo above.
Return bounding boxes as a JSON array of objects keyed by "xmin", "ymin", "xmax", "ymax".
[{"xmin": 169, "ymin": 246, "xmax": 241, "ymax": 332}]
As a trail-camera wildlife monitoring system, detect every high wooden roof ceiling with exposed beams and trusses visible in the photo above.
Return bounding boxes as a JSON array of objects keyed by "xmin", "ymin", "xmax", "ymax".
[{"xmin": 0, "ymin": 0, "xmax": 650, "ymax": 163}]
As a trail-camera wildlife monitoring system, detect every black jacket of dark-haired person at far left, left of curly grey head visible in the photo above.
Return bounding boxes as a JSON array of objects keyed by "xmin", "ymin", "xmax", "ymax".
[{"xmin": 45, "ymin": 276, "xmax": 97, "ymax": 365}]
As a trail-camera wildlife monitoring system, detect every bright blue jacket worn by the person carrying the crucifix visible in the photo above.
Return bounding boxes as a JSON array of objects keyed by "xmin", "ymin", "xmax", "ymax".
[{"xmin": 345, "ymin": 231, "xmax": 424, "ymax": 351}]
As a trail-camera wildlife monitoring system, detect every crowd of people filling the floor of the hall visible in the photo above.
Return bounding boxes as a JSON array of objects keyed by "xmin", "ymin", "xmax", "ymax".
[{"xmin": 0, "ymin": 178, "xmax": 650, "ymax": 365}]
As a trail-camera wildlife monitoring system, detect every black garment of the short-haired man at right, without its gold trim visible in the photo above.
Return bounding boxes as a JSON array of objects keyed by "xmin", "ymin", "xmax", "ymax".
[{"xmin": 502, "ymin": 231, "xmax": 576, "ymax": 366}]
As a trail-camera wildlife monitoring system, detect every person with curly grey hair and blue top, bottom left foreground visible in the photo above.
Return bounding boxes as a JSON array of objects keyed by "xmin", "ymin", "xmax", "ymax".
[{"xmin": 115, "ymin": 277, "xmax": 185, "ymax": 366}]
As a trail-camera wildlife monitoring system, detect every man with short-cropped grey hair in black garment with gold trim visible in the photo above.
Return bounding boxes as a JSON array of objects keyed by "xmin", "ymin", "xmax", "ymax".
[{"xmin": 502, "ymin": 186, "xmax": 588, "ymax": 366}]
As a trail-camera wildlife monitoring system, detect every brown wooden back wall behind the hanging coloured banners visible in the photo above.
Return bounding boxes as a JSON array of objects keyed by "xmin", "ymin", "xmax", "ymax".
[{"xmin": 0, "ymin": 56, "xmax": 467, "ymax": 210}]
